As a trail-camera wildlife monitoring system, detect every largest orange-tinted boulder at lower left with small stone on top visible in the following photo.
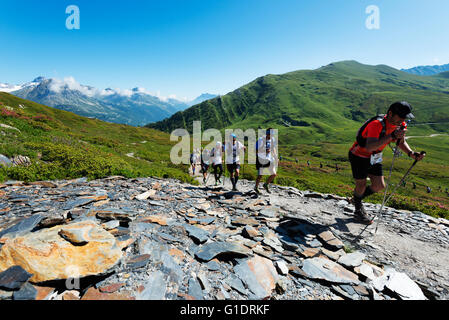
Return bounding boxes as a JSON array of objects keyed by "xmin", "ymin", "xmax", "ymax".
[{"xmin": 0, "ymin": 221, "xmax": 122, "ymax": 283}]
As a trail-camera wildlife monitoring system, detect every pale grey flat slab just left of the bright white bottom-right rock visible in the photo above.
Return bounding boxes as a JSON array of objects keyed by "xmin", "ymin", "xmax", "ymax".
[{"xmin": 302, "ymin": 258, "xmax": 360, "ymax": 284}]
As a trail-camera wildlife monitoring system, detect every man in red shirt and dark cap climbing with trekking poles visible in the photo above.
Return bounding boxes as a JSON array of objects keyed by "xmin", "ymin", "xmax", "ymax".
[{"xmin": 349, "ymin": 101, "xmax": 425, "ymax": 224}]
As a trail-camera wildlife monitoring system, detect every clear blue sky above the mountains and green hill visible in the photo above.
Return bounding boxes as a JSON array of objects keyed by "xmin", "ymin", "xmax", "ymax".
[{"xmin": 0, "ymin": 0, "xmax": 449, "ymax": 99}]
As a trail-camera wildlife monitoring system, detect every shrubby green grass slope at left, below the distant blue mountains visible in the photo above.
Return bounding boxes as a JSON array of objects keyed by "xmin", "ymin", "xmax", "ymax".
[{"xmin": 0, "ymin": 92, "xmax": 195, "ymax": 183}]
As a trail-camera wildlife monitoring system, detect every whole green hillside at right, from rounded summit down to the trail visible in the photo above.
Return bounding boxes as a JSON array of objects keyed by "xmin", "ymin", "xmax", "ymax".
[{"xmin": 149, "ymin": 61, "xmax": 449, "ymax": 218}]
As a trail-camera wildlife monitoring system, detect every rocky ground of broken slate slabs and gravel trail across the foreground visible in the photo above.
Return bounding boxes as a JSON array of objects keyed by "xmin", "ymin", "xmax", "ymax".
[{"xmin": 0, "ymin": 172, "xmax": 449, "ymax": 300}]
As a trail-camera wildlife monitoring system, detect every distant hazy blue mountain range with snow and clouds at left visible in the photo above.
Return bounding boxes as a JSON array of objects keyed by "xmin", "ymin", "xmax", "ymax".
[{"xmin": 0, "ymin": 77, "xmax": 216, "ymax": 126}]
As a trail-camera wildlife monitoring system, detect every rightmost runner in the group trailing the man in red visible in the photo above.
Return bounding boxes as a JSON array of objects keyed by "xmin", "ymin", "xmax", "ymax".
[{"xmin": 254, "ymin": 128, "xmax": 277, "ymax": 194}]
